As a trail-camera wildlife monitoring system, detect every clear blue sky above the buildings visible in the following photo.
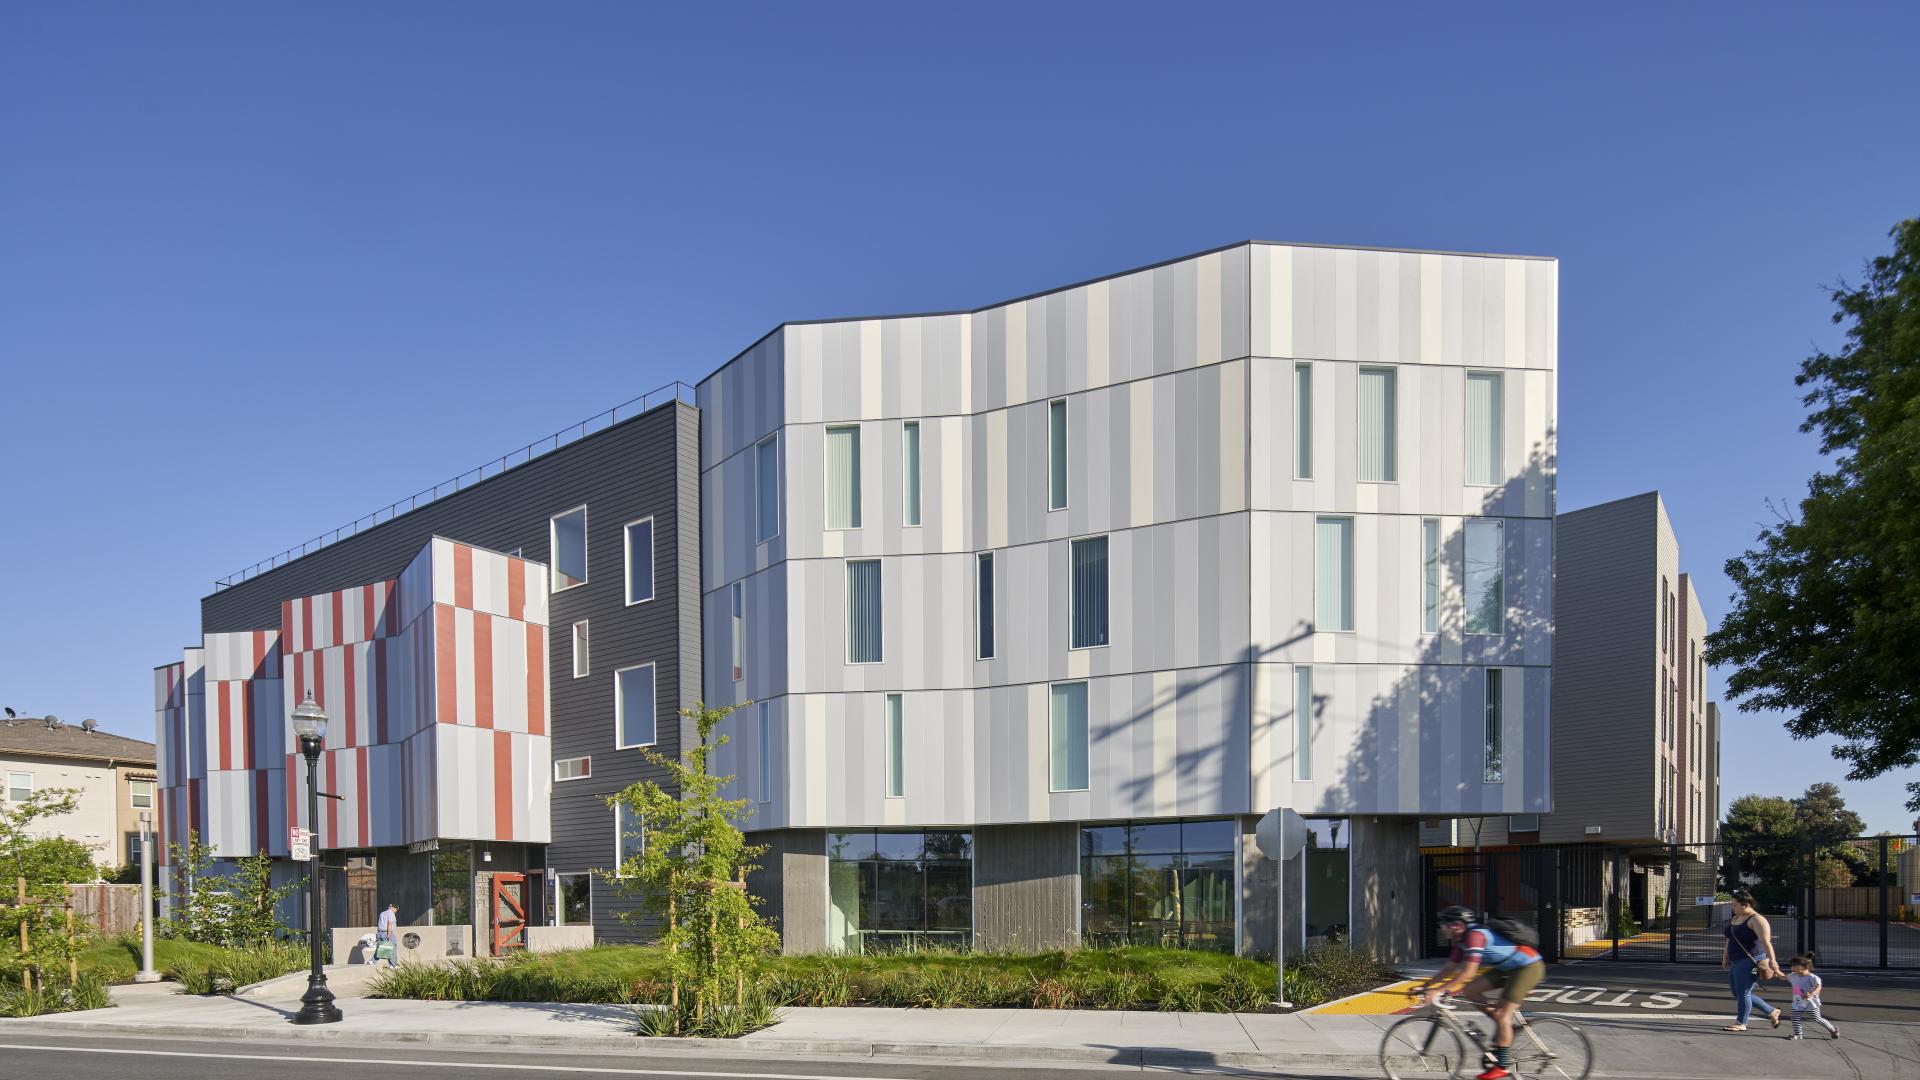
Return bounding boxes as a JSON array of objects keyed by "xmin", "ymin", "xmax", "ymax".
[{"xmin": 0, "ymin": 2, "xmax": 1920, "ymax": 830}]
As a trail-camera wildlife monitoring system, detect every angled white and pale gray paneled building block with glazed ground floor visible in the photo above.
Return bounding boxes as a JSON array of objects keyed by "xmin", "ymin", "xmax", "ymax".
[{"xmin": 699, "ymin": 242, "xmax": 1559, "ymax": 957}]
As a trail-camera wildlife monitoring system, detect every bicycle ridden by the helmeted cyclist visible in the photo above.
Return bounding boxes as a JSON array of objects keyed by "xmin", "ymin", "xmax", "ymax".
[{"xmin": 1380, "ymin": 994, "xmax": 1594, "ymax": 1080}]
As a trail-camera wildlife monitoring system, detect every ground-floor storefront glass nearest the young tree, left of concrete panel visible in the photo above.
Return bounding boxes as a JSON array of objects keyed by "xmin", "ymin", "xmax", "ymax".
[{"xmin": 828, "ymin": 828, "xmax": 973, "ymax": 953}]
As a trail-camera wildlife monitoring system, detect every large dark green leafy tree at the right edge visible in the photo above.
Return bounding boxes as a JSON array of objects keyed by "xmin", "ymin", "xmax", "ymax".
[{"xmin": 1707, "ymin": 219, "xmax": 1920, "ymax": 809}]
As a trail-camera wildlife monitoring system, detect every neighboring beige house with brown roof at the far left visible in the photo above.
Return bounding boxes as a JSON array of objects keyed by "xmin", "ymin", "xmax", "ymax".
[{"xmin": 0, "ymin": 717, "xmax": 157, "ymax": 869}]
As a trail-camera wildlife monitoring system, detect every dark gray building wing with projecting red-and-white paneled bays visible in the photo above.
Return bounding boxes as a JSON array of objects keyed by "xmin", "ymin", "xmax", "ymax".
[{"xmin": 156, "ymin": 384, "xmax": 701, "ymax": 951}]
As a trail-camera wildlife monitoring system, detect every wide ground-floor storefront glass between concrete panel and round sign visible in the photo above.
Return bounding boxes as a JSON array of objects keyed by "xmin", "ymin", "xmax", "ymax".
[{"xmin": 1081, "ymin": 821, "xmax": 1235, "ymax": 953}]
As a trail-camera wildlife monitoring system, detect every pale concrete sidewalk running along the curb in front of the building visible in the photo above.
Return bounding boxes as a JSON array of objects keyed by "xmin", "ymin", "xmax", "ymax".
[{"xmin": 0, "ymin": 986, "xmax": 1920, "ymax": 1080}]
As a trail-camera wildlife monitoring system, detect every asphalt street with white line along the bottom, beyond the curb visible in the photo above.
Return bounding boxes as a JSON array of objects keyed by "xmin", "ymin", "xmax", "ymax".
[{"xmin": 0, "ymin": 1030, "xmax": 1377, "ymax": 1080}]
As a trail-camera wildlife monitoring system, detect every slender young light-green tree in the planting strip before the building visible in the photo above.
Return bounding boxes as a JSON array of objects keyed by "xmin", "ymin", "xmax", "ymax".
[{"xmin": 603, "ymin": 701, "xmax": 780, "ymax": 1034}]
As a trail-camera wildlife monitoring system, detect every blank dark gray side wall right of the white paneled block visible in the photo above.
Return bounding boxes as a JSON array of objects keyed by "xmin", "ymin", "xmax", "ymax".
[{"xmin": 1540, "ymin": 492, "xmax": 1661, "ymax": 844}]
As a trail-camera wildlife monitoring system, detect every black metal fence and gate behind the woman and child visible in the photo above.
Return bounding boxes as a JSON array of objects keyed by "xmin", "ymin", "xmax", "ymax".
[{"xmin": 1421, "ymin": 836, "xmax": 1920, "ymax": 969}]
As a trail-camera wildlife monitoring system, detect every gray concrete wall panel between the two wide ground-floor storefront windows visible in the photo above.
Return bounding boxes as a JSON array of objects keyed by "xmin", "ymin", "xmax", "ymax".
[{"xmin": 973, "ymin": 822, "xmax": 1081, "ymax": 951}]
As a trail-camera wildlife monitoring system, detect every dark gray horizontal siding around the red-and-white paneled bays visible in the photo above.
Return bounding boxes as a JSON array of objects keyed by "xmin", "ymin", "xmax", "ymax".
[{"xmin": 200, "ymin": 402, "xmax": 701, "ymax": 940}]
